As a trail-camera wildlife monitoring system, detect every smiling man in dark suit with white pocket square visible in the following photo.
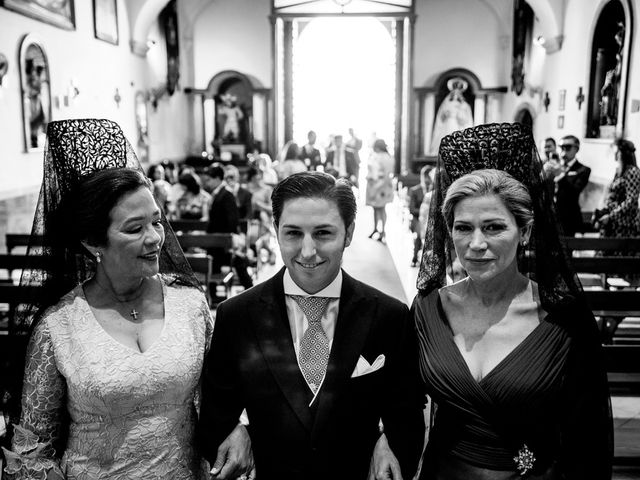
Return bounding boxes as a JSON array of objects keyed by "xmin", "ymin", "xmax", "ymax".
[{"xmin": 199, "ymin": 172, "xmax": 424, "ymax": 480}]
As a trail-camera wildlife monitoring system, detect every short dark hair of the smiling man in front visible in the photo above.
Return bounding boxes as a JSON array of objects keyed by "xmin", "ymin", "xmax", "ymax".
[{"xmin": 271, "ymin": 172, "xmax": 357, "ymax": 229}]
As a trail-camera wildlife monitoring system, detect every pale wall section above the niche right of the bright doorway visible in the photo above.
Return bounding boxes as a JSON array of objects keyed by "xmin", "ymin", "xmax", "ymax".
[{"xmin": 413, "ymin": 0, "xmax": 511, "ymax": 88}]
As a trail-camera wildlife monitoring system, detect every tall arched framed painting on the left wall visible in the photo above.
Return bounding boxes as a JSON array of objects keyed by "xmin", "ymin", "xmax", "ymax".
[{"xmin": 20, "ymin": 35, "xmax": 51, "ymax": 152}]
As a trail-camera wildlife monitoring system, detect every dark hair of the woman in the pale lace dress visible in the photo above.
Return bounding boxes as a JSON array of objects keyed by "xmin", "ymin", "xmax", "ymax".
[{"xmin": 59, "ymin": 168, "xmax": 153, "ymax": 248}]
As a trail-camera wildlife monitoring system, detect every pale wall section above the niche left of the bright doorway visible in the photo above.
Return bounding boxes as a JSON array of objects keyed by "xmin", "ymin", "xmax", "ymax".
[{"xmin": 193, "ymin": 0, "xmax": 272, "ymax": 88}]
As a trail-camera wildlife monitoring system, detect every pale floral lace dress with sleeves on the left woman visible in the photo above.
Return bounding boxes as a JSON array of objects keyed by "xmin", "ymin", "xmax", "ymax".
[{"xmin": 5, "ymin": 281, "xmax": 212, "ymax": 480}]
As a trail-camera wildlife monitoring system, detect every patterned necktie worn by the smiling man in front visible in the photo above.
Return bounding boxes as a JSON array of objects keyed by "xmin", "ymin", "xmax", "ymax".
[{"xmin": 291, "ymin": 295, "xmax": 331, "ymax": 395}]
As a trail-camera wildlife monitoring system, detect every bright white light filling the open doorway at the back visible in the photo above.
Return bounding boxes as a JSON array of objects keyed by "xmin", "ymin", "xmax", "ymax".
[{"xmin": 293, "ymin": 17, "xmax": 396, "ymax": 155}]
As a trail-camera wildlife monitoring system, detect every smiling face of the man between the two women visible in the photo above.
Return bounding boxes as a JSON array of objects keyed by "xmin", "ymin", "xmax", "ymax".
[{"xmin": 277, "ymin": 198, "xmax": 355, "ymax": 294}]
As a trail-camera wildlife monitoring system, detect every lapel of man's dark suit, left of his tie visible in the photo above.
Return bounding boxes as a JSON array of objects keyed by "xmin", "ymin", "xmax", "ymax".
[{"xmin": 251, "ymin": 268, "xmax": 313, "ymax": 430}]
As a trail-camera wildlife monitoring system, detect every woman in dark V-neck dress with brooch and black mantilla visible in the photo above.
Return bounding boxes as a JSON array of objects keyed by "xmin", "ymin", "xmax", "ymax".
[{"xmin": 412, "ymin": 124, "xmax": 613, "ymax": 480}]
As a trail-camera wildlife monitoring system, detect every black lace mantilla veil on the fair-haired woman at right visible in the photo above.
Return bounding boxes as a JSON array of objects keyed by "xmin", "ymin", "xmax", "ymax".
[{"xmin": 414, "ymin": 123, "xmax": 613, "ymax": 479}]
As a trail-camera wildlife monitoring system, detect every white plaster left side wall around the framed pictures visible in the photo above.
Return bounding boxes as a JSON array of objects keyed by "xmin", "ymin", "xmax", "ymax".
[{"xmin": 0, "ymin": 0, "xmax": 186, "ymax": 198}]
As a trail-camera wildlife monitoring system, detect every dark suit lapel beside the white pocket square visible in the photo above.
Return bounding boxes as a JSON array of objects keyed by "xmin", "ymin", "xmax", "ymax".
[{"xmin": 312, "ymin": 271, "xmax": 377, "ymax": 437}]
